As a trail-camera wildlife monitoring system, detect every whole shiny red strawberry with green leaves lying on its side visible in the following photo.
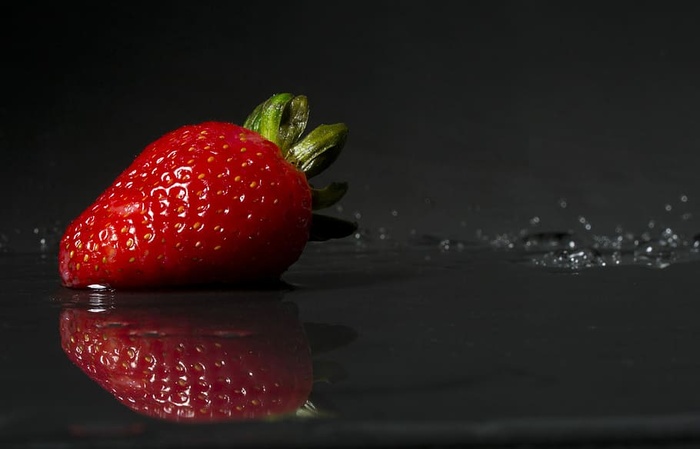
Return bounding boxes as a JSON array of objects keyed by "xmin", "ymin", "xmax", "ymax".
[{"xmin": 58, "ymin": 93, "xmax": 356, "ymax": 289}]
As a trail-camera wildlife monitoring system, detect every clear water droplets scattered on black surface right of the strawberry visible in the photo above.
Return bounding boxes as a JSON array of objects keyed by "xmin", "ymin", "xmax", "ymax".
[{"xmin": 308, "ymin": 194, "xmax": 700, "ymax": 272}]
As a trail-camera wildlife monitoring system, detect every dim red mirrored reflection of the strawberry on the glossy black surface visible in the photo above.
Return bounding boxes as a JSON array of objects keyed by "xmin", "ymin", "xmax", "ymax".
[{"xmin": 60, "ymin": 298, "xmax": 313, "ymax": 422}]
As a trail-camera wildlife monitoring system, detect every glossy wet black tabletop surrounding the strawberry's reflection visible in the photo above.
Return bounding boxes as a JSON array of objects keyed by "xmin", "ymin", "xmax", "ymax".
[{"xmin": 0, "ymin": 238, "xmax": 700, "ymax": 447}]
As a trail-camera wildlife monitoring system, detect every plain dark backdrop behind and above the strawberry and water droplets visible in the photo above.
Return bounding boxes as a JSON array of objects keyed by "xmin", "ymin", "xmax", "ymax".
[{"xmin": 0, "ymin": 1, "xmax": 700, "ymax": 251}]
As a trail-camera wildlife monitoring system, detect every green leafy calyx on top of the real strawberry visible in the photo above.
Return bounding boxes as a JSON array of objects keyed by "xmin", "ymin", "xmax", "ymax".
[{"xmin": 243, "ymin": 93, "xmax": 357, "ymax": 241}]
